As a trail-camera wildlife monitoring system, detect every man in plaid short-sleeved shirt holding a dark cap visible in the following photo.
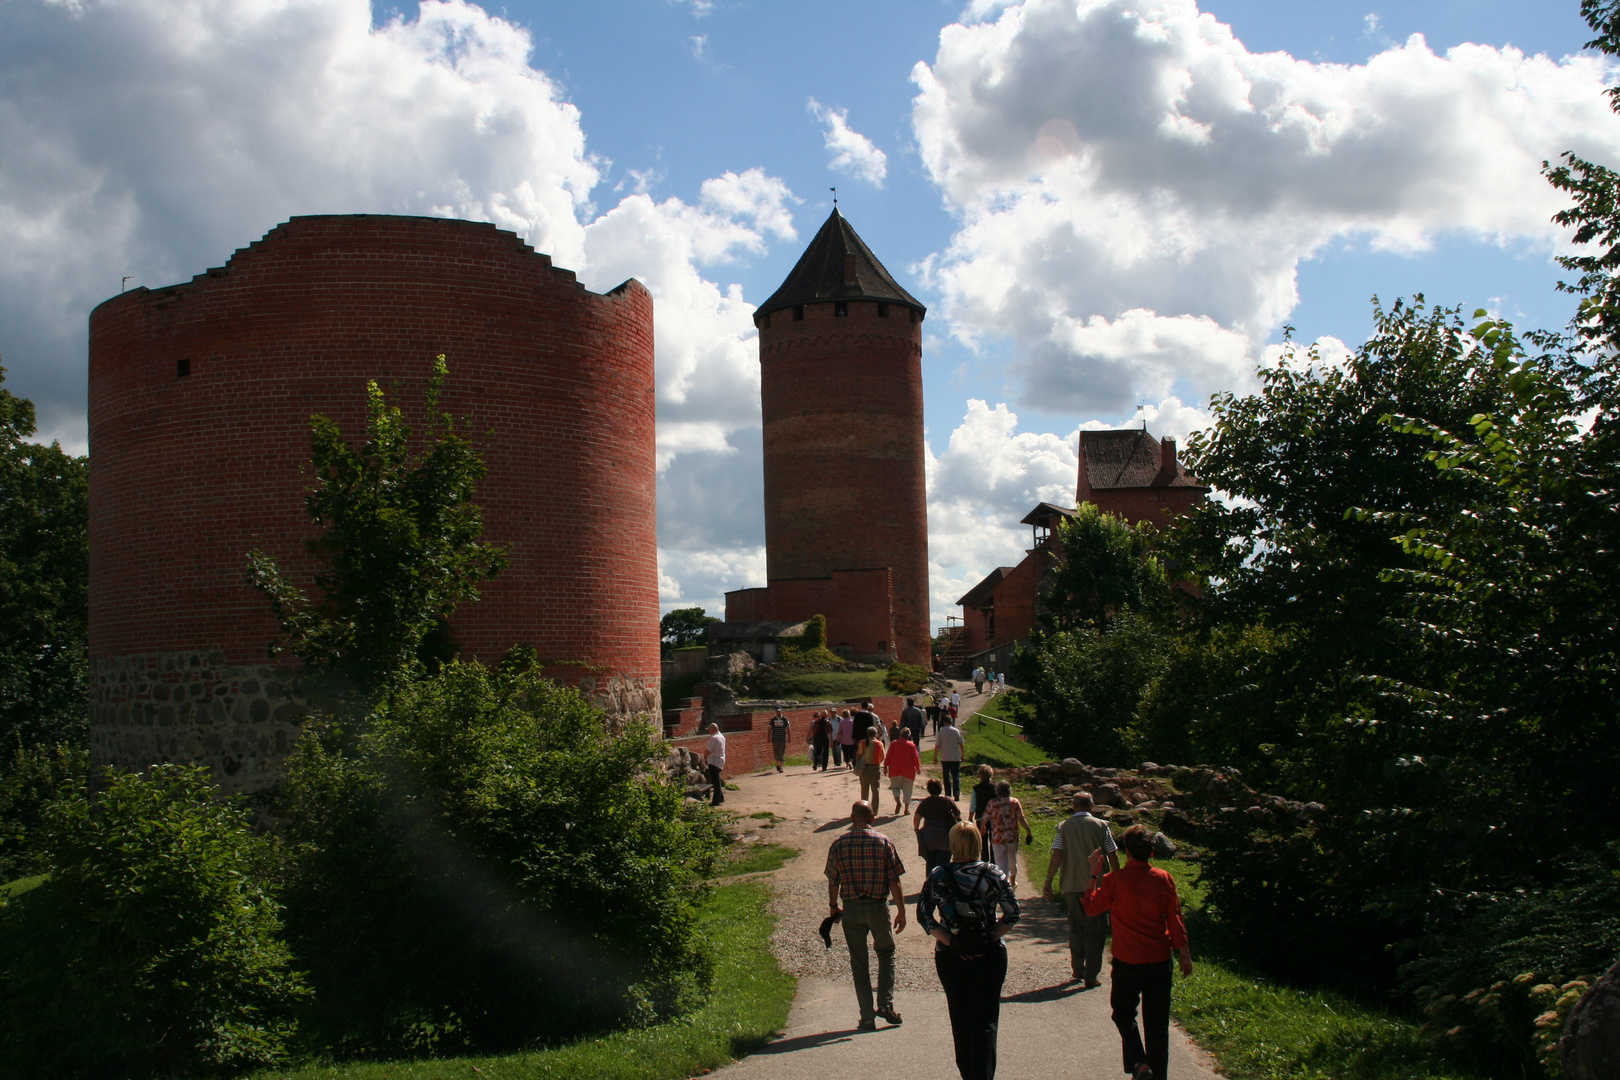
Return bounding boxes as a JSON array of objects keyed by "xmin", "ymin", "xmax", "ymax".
[{"xmin": 826, "ymin": 803, "xmax": 906, "ymax": 1031}]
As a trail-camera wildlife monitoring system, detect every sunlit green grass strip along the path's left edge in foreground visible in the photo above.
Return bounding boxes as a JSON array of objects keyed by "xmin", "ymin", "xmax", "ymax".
[{"xmin": 243, "ymin": 882, "xmax": 794, "ymax": 1080}]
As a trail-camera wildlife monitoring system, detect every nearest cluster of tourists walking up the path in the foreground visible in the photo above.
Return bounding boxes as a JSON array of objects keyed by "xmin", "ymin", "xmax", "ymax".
[{"xmin": 825, "ymin": 786, "xmax": 1192, "ymax": 1080}]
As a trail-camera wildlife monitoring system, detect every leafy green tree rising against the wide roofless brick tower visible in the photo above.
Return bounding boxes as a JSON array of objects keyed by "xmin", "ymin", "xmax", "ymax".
[{"xmin": 248, "ymin": 356, "xmax": 505, "ymax": 699}]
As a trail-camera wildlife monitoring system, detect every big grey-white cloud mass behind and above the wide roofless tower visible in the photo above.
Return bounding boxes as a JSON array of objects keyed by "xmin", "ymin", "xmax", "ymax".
[{"xmin": 0, "ymin": 0, "xmax": 797, "ymax": 615}]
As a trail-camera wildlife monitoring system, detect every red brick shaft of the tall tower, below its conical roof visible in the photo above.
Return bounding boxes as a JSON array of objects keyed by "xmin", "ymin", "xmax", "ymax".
[{"xmin": 741, "ymin": 301, "xmax": 932, "ymax": 665}]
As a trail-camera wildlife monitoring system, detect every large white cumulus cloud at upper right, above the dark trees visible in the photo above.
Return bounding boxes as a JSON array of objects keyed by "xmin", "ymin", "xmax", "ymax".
[{"xmin": 912, "ymin": 0, "xmax": 1620, "ymax": 416}]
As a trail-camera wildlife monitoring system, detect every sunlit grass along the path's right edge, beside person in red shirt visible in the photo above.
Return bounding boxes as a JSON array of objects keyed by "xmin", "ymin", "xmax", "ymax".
[{"xmin": 1016, "ymin": 785, "xmax": 1466, "ymax": 1080}]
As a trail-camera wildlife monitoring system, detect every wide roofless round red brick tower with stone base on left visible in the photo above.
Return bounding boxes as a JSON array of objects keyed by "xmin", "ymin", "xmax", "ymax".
[{"xmin": 89, "ymin": 215, "xmax": 659, "ymax": 790}]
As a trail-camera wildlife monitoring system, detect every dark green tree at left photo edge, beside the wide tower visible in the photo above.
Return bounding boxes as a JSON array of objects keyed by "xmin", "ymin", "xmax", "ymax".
[{"xmin": 0, "ymin": 368, "xmax": 89, "ymax": 748}]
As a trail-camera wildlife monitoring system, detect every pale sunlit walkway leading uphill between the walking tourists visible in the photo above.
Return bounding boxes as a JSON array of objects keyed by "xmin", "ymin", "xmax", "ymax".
[{"xmin": 714, "ymin": 683, "xmax": 1220, "ymax": 1080}]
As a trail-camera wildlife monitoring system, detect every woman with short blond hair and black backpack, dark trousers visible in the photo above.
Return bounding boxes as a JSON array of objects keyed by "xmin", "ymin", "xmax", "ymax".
[{"xmin": 917, "ymin": 821, "xmax": 1019, "ymax": 1080}]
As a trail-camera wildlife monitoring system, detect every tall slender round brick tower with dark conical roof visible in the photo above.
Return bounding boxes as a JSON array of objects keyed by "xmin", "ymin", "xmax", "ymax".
[{"xmin": 727, "ymin": 209, "xmax": 932, "ymax": 665}]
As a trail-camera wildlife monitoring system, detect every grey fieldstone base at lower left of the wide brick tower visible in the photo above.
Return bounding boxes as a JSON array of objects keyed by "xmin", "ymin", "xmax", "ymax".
[{"xmin": 91, "ymin": 649, "xmax": 305, "ymax": 795}]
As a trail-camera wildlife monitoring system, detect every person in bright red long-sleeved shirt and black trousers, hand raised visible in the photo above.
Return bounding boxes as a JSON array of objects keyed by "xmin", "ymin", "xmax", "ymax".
[{"xmin": 1081, "ymin": 826, "xmax": 1192, "ymax": 1080}]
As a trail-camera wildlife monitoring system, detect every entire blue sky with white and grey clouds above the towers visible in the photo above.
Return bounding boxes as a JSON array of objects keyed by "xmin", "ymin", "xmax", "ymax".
[{"xmin": 0, "ymin": 0, "xmax": 1620, "ymax": 627}]
